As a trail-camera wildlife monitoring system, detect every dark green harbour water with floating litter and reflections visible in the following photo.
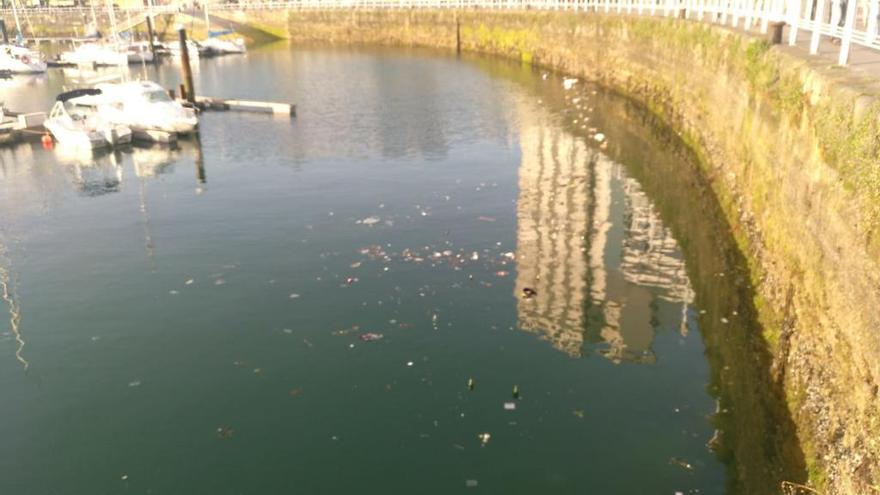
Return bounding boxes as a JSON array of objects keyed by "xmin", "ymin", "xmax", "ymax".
[{"xmin": 0, "ymin": 46, "xmax": 801, "ymax": 495}]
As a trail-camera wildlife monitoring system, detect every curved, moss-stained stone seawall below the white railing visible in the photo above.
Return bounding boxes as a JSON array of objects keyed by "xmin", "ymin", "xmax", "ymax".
[{"xmin": 260, "ymin": 10, "xmax": 880, "ymax": 494}]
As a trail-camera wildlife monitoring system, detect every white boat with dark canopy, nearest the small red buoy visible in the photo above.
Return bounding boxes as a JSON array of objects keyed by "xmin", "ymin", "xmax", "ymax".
[{"xmin": 43, "ymin": 89, "xmax": 131, "ymax": 149}]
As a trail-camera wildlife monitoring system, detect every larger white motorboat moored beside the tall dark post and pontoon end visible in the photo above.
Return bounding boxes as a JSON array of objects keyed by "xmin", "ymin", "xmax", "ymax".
[{"xmin": 73, "ymin": 81, "xmax": 199, "ymax": 142}]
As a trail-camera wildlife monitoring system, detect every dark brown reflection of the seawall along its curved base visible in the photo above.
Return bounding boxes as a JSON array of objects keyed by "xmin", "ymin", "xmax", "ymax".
[{"xmin": 470, "ymin": 55, "xmax": 806, "ymax": 494}]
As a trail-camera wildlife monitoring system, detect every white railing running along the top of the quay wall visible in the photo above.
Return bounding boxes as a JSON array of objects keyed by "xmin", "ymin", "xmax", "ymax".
[{"xmin": 0, "ymin": 0, "xmax": 880, "ymax": 65}]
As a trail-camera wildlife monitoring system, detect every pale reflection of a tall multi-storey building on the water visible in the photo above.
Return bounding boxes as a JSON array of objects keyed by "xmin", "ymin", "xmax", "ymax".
[{"xmin": 516, "ymin": 105, "xmax": 693, "ymax": 363}]
